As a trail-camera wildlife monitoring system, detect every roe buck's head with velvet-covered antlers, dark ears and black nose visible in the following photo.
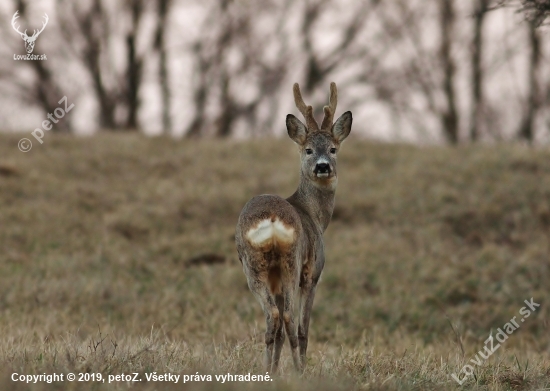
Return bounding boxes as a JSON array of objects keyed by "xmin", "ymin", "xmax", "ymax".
[{"xmin": 286, "ymin": 83, "xmax": 353, "ymax": 188}]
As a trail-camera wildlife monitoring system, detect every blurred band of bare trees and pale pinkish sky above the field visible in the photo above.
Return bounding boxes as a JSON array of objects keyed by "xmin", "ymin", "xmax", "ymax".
[{"xmin": 0, "ymin": 0, "xmax": 550, "ymax": 143}]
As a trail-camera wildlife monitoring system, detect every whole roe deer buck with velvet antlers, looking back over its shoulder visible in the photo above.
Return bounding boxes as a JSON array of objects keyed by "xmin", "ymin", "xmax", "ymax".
[{"xmin": 235, "ymin": 83, "xmax": 352, "ymax": 372}]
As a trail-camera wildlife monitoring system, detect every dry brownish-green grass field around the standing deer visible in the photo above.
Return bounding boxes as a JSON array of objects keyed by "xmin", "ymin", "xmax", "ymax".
[{"xmin": 0, "ymin": 134, "xmax": 550, "ymax": 391}]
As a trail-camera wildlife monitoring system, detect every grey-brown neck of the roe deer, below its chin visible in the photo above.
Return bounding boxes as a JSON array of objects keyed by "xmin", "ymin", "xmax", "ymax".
[{"xmin": 288, "ymin": 175, "xmax": 336, "ymax": 232}]
